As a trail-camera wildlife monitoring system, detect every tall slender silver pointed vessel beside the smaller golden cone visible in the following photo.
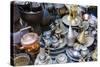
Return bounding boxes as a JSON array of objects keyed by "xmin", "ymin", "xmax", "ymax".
[{"xmin": 68, "ymin": 26, "xmax": 75, "ymax": 46}]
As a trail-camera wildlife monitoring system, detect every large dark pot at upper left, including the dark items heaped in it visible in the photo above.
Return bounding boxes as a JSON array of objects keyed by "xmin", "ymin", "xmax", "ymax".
[{"xmin": 18, "ymin": 2, "xmax": 43, "ymax": 25}]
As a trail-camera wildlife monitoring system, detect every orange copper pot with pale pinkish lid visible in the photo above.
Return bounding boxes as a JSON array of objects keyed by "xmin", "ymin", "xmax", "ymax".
[{"xmin": 20, "ymin": 33, "xmax": 40, "ymax": 55}]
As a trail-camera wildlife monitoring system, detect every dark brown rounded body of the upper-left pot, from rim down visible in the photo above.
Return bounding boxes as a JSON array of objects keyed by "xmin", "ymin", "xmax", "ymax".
[{"xmin": 20, "ymin": 11, "xmax": 43, "ymax": 25}]
